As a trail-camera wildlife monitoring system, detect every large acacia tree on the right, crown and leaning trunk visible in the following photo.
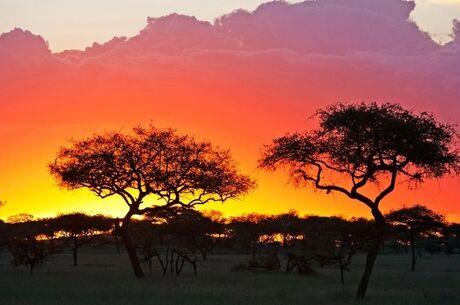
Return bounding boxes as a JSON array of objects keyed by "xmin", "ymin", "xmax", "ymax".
[{"xmin": 259, "ymin": 103, "xmax": 460, "ymax": 298}]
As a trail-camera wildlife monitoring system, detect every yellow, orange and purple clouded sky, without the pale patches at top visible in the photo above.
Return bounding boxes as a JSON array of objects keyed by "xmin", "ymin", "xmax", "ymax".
[{"xmin": 0, "ymin": 1, "xmax": 460, "ymax": 221}]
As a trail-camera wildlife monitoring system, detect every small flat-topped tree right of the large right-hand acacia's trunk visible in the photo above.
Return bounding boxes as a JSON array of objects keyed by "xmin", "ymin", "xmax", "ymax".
[{"xmin": 386, "ymin": 205, "xmax": 445, "ymax": 271}]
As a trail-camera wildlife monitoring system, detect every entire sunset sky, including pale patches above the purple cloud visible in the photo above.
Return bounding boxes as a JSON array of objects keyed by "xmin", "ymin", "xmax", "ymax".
[{"xmin": 0, "ymin": 0, "xmax": 460, "ymax": 221}]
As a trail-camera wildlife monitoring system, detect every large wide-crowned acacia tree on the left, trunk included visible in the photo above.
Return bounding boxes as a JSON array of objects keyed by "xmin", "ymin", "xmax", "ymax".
[{"xmin": 49, "ymin": 126, "xmax": 254, "ymax": 277}]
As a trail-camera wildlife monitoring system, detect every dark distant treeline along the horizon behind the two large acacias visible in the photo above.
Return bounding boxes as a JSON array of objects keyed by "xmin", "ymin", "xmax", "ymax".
[{"xmin": 0, "ymin": 205, "xmax": 460, "ymax": 282}]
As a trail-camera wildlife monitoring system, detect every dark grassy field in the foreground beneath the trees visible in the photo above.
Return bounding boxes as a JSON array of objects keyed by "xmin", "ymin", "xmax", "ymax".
[{"xmin": 0, "ymin": 249, "xmax": 460, "ymax": 305}]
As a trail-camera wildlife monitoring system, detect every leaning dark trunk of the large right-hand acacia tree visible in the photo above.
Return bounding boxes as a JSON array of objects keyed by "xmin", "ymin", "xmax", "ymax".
[{"xmin": 356, "ymin": 208, "xmax": 385, "ymax": 299}]
